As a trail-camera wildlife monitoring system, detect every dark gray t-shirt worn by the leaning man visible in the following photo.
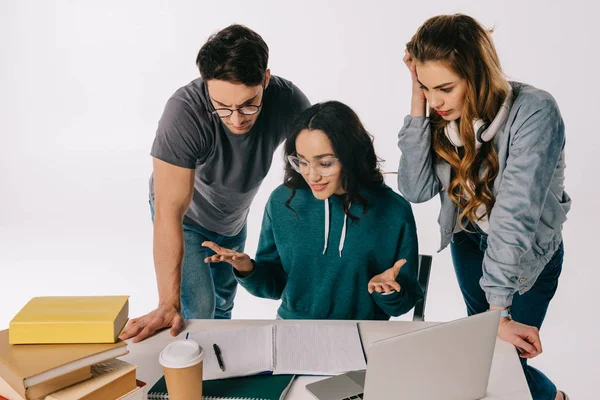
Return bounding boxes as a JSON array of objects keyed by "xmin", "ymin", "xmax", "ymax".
[{"xmin": 150, "ymin": 76, "xmax": 310, "ymax": 236}]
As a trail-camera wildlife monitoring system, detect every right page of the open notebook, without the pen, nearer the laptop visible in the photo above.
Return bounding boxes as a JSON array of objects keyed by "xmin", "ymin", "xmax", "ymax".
[{"xmin": 274, "ymin": 322, "xmax": 367, "ymax": 375}]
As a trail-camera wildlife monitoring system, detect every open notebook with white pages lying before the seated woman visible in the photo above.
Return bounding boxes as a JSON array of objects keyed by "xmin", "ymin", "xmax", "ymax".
[{"xmin": 190, "ymin": 322, "xmax": 366, "ymax": 380}]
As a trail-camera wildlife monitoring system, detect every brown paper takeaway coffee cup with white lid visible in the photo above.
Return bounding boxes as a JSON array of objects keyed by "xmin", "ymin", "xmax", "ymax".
[{"xmin": 159, "ymin": 340, "xmax": 204, "ymax": 400}]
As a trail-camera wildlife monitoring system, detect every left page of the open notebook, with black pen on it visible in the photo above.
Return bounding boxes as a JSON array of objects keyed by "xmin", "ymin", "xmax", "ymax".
[{"xmin": 190, "ymin": 326, "xmax": 273, "ymax": 380}]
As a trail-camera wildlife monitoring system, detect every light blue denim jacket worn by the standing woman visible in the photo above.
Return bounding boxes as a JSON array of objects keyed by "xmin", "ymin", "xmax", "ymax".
[{"xmin": 398, "ymin": 82, "xmax": 571, "ymax": 306}]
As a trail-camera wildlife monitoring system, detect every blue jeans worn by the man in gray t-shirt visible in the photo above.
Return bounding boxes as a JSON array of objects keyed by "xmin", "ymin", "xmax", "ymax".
[{"xmin": 150, "ymin": 201, "xmax": 246, "ymax": 319}]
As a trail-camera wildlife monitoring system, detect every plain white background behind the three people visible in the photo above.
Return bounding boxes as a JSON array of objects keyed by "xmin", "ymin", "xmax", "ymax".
[{"xmin": 0, "ymin": 0, "xmax": 600, "ymax": 399}]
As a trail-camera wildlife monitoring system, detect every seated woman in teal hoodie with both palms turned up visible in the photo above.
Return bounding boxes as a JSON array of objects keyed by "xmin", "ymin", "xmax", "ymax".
[{"xmin": 204, "ymin": 101, "xmax": 423, "ymax": 320}]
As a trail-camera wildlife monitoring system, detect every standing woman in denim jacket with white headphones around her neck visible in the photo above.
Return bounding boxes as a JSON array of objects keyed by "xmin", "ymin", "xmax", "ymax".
[{"xmin": 398, "ymin": 14, "xmax": 571, "ymax": 400}]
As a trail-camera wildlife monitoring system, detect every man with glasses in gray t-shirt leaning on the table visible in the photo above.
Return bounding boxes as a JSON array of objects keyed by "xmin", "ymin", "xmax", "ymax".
[{"xmin": 120, "ymin": 25, "xmax": 310, "ymax": 342}]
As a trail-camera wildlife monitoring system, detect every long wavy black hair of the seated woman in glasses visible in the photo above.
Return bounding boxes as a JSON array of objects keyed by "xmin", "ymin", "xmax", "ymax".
[{"xmin": 284, "ymin": 101, "xmax": 383, "ymax": 220}]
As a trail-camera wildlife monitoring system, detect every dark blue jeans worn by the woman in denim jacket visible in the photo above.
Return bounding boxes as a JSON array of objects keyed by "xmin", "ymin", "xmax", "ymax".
[{"xmin": 450, "ymin": 224, "xmax": 564, "ymax": 400}]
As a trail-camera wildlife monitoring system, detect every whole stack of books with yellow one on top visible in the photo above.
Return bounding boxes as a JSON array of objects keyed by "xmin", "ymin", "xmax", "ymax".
[{"xmin": 0, "ymin": 296, "xmax": 143, "ymax": 400}]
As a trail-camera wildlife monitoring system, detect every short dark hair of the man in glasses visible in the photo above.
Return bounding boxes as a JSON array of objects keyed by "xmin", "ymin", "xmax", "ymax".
[{"xmin": 196, "ymin": 24, "xmax": 269, "ymax": 86}]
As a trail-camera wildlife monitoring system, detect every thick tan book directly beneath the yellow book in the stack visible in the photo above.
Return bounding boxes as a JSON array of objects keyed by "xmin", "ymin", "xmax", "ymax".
[{"xmin": 0, "ymin": 330, "xmax": 128, "ymax": 399}]
